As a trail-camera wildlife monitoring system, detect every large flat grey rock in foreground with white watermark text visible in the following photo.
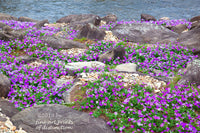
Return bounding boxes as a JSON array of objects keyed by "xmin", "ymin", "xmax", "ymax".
[{"xmin": 11, "ymin": 104, "xmax": 114, "ymax": 133}]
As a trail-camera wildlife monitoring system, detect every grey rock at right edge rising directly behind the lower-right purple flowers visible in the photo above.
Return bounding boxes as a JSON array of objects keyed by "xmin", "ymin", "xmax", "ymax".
[{"xmin": 178, "ymin": 59, "xmax": 200, "ymax": 86}]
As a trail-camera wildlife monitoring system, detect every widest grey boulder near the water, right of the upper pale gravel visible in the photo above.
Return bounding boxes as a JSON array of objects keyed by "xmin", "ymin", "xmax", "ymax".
[{"xmin": 112, "ymin": 23, "xmax": 178, "ymax": 44}]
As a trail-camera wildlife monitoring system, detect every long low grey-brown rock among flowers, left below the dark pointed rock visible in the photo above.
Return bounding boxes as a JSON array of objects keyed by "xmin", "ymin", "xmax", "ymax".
[{"xmin": 40, "ymin": 36, "xmax": 86, "ymax": 49}]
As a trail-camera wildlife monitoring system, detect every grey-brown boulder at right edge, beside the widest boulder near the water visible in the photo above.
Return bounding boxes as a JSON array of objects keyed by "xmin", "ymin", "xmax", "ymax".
[{"xmin": 178, "ymin": 28, "xmax": 200, "ymax": 54}]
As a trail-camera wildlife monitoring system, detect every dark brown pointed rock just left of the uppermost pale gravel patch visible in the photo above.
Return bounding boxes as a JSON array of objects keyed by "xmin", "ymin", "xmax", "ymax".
[{"xmin": 77, "ymin": 23, "xmax": 106, "ymax": 40}]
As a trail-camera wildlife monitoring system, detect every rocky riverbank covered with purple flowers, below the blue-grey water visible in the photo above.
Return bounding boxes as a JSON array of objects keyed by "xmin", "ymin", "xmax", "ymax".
[{"xmin": 0, "ymin": 13, "xmax": 200, "ymax": 133}]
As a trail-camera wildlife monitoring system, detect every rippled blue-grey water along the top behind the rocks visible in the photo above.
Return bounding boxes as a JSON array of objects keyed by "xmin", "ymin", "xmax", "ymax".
[{"xmin": 0, "ymin": 0, "xmax": 200, "ymax": 22}]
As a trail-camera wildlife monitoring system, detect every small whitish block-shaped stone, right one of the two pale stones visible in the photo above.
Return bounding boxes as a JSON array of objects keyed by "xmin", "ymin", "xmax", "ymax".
[{"xmin": 115, "ymin": 63, "xmax": 137, "ymax": 72}]
